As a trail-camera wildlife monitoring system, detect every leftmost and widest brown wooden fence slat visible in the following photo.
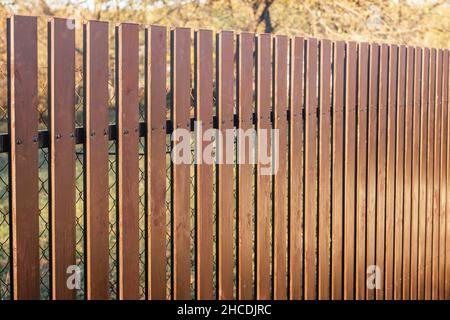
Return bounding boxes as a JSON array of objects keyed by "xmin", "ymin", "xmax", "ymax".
[{"xmin": 8, "ymin": 16, "xmax": 40, "ymax": 299}]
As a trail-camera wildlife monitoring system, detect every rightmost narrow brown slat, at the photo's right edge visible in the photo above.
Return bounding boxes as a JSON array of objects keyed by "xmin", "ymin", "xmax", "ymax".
[{"xmin": 438, "ymin": 50, "xmax": 448, "ymax": 300}]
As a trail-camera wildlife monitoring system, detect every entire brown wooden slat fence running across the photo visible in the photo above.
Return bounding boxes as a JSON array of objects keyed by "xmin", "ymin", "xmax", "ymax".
[{"xmin": 0, "ymin": 16, "xmax": 450, "ymax": 299}]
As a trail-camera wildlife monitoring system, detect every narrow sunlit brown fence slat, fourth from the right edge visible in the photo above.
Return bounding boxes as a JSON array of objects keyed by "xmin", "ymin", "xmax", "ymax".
[{"xmin": 411, "ymin": 48, "xmax": 422, "ymax": 300}]
